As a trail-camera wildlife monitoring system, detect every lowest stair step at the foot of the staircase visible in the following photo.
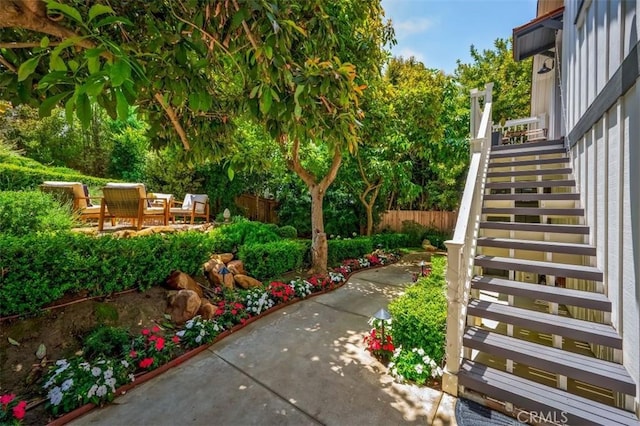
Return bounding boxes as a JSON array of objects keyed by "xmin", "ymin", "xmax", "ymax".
[{"xmin": 458, "ymin": 359, "xmax": 638, "ymax": 426}]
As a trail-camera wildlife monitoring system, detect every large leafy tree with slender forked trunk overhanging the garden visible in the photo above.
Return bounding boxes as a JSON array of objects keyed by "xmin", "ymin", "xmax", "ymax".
[{"xmin": 0, "ymin": 0, "xmax": 393, "ymax": 271}]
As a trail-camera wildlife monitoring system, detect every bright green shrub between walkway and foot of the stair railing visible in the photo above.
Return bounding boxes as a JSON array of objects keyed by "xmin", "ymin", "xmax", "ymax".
[{"xmin": 389, "ymin": 256, "xmax": 447, "ymax": 364}]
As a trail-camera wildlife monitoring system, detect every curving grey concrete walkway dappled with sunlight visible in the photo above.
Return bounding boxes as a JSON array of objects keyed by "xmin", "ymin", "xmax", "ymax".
[{"xmin": 73, "ymin": 255, "xmax": 455, "ymax": 426}]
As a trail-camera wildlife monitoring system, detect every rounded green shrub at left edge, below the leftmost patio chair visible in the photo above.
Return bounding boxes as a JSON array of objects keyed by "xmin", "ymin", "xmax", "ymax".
[{"xmin": 0, "ymin": 191, "xmax": 75, "ymax": 235}]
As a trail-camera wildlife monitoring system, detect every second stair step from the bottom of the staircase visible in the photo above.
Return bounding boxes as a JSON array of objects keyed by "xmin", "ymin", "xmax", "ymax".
[{"xmin": 463, "ymin": 327, "xmax": 636, "ymax": 396}]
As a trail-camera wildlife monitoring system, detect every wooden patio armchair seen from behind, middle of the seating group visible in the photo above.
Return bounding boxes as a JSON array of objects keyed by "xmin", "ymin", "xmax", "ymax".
[{"xmin": 98, "ymin": 183, "xmax": 169, "ymax": 231}]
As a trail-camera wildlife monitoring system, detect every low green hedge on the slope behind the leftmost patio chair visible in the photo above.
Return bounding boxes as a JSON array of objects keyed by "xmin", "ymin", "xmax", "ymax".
[{"xmin": 0, "ymin": 162, "xmax": 113, "ymax": 191}]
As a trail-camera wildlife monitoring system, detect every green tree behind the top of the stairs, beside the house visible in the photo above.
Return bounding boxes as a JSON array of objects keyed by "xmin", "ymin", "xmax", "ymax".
[{"xmin": 455, "ymin": 38, "xmax": 533, "ymax": 123}]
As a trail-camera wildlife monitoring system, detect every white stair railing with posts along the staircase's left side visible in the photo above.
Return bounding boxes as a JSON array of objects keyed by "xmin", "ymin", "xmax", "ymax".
[{"xmin": 442, "ymin": 83, "xmax": 493, "ymax": 396}]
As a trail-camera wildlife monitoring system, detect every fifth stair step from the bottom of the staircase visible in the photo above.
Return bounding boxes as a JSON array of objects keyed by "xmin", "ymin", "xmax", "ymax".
[{"xmin": 475, "ymin": 255, "xmax": 602, "ymax": 281}]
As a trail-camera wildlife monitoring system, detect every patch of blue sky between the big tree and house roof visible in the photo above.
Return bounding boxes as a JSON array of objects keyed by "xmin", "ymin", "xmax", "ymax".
[{"xmin": 382, "ymin": 0, "xmax": 537, "ymax": 74}]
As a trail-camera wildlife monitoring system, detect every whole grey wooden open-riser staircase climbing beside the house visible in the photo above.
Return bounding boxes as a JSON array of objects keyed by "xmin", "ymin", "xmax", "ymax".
[{"xmin": 458, "ymin": 141, "xmax": 639, "ymax": 425}]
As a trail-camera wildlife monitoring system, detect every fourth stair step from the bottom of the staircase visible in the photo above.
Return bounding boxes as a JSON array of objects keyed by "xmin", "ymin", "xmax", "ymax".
[{"xmin": 471, "ymin": 276, "xmax": 611, "ymax": 312}]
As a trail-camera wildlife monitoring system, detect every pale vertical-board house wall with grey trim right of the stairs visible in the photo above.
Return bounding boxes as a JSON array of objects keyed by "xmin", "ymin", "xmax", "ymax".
[{"xmin": 561, "ymin": 0, "xmax": 640, "ymax": 408}]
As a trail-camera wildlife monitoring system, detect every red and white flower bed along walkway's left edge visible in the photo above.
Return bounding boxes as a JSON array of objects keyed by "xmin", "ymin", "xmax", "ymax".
[{"xmin": 30, "ymin": 253, "xmax": 398, "ymax": 424}]
